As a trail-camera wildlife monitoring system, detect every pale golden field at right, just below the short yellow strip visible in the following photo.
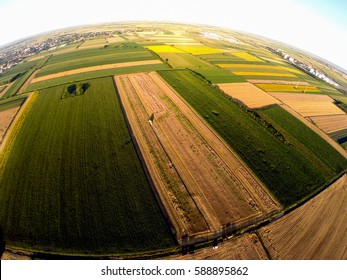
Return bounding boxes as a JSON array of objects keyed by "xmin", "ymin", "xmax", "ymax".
[{"xmin": 271, "ymin": 92, "xmax": 344, "ymax": 117}]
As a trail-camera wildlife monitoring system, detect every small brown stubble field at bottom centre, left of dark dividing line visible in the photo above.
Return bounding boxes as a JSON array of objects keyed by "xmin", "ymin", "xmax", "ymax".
[{"xmin": 167, "ymin": 233, "xmax": 268, "ymax": 260}]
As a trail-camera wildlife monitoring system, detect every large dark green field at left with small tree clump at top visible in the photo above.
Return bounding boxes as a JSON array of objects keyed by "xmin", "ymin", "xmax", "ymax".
[{"xmin": 0, "ymin": 78, "xmax": 175, "ymax": 255}]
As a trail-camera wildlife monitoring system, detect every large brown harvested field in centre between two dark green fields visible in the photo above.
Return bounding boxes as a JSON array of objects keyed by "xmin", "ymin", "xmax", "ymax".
[{"xmin": 115, "ymin": 73, "xmax": 279, "ymax": 241}]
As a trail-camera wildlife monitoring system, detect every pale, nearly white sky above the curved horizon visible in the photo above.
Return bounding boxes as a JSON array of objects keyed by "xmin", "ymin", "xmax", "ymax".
[{"xmin": 0, "ymin": 0, "xmax": 347, "ymax": 69}]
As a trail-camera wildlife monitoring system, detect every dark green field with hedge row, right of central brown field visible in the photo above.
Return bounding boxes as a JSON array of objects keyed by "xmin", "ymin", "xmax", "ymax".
[{"xmin": 159, "ymin": 70, "xmax": 347, "ymax": 207}]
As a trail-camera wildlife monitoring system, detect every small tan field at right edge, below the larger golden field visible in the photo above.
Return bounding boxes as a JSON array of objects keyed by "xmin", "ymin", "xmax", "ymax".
[{"xmin": 310, "ymin": 114, "xmax": 347, "ymax": 133}]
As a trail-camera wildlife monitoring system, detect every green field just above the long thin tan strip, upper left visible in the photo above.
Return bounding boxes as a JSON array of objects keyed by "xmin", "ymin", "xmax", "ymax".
[{"xmin": 37, "ymin": 44, "xmax": 154, "ymax": 77}]
